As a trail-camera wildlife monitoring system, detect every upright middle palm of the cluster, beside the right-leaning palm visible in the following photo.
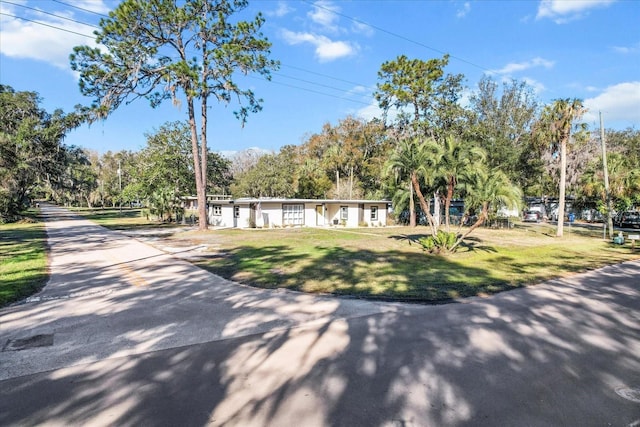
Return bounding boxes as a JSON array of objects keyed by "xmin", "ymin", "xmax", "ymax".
[{"xmin": 436, "ymin": 137, "xmax": 487, "ymax": 232}]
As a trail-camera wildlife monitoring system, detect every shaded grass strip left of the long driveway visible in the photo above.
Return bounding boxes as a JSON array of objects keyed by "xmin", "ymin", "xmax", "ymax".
[{"xmin": 0, "ymin": 216, "xmax": 48, "ymax": 307}]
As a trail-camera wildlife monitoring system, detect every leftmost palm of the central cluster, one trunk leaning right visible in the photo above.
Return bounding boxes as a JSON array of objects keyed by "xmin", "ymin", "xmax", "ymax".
[{"xmin": 384, "ymin": 138, "xmax": 438, "ymax": 235}]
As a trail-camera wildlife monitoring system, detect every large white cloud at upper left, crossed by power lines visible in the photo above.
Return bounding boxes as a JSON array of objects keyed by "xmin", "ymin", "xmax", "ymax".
[{"xmin": 0, "ymin": 10, "xmax": 97, "ymax": 70}]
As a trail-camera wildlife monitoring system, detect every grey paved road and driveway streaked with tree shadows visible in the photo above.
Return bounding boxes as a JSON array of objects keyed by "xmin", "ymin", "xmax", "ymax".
[{"xmin": 0, "ymin": 206, "xmax": 640, "ymax": 427}]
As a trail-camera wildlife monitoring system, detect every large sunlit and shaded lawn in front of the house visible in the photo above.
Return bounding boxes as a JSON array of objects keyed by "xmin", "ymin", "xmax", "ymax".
[{"xmin": 160, "ymin": 224, "xmax": 640, "ymax": 302}]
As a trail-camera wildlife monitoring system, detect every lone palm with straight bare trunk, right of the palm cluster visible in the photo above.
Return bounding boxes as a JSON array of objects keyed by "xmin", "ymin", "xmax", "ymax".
[{"xmin": 542, "ymin": 98, "xmax": 587, "ymax": 237}]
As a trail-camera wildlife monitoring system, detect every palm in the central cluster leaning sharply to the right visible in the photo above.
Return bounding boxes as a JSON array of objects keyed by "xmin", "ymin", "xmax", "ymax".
[{"xmin": 449, "ymin": 165, "xmax": 522, "ymax": 251}]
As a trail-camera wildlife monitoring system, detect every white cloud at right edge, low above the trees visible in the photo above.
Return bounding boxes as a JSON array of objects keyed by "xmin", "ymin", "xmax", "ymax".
[{"xmin": 584, "ymin": 81, "xmax": 640, "ymax": 126}]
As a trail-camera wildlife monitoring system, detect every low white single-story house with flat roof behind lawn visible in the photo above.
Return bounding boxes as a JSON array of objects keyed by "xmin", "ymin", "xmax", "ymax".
[{"xmin": 185, "ymin": 198, "xmax": 391, "ymax": 228}]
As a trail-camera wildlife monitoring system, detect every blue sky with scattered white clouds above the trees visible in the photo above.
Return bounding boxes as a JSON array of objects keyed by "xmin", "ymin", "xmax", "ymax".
[{"xmin": 0, "ymin": 0, "xmax": 640, "ymax": 155}]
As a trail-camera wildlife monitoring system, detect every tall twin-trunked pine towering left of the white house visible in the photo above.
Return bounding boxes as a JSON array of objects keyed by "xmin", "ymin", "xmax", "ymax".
[{"xmin": 71, "ymin": 0, "xmax": 278, "ymax": 228}]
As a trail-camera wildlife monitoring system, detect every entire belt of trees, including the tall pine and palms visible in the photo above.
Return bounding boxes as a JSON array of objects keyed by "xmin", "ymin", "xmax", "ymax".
[{"xmin": 0, "ymin": 0, "xmax": 640, "ymax": 251}]
